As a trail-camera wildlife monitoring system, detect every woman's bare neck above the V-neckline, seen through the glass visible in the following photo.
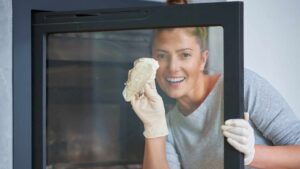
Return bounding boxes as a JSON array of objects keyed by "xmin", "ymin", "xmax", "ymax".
[{"xmin": 177, "ymin": 74, "xmax": 220, "ymax": 116}]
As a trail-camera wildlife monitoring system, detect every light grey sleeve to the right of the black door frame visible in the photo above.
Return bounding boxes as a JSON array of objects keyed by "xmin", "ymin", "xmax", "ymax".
[{"xmin": 244, "ymin": 69, "xmax": 300, "ymax": 145}]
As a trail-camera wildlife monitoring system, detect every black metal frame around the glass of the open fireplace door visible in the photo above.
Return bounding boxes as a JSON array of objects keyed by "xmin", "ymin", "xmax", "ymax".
[{"xmin": 32, "ymin": 2, "xmax": 244, "ymax": 169}]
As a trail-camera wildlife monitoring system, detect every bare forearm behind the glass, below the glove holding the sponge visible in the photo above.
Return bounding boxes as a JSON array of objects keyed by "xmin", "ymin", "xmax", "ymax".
[{"xmin": 143, "ymin": 136, "xmax": 168, "ymax": 169}]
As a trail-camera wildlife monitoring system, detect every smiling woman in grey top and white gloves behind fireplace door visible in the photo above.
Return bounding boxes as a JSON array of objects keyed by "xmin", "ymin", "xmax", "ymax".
[{"xmin": 131, "ymin": 2, "xmax": 300, "ymax": 169}]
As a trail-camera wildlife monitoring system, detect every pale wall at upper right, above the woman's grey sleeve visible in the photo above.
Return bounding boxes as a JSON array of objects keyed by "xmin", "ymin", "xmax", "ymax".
[{"xmin": 240, "ymin": 0, "xmax": 300, "ymax": 117}]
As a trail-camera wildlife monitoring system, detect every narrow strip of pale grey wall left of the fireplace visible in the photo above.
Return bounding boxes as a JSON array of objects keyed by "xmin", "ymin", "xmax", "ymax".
[{"xmin": 0, "ymin": 0, "xmax": 12, "ymax": 169}]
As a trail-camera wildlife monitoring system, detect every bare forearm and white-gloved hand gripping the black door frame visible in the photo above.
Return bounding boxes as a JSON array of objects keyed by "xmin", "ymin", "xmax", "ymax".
[{"xmin": 222, "ymin": 119, "xmax": 300, "ymax": 169}]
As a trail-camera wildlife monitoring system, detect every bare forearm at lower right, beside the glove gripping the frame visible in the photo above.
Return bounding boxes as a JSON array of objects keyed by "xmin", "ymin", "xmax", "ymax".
[{"xmin": 250, "ymin": 145, "xmax": 300, "ymax": 169}]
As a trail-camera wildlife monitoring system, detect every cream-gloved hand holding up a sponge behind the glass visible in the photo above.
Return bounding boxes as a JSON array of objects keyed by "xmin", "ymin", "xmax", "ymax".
[{"xmin": 131, "ymin": 80, "xmax": 168, "ymax": 138}]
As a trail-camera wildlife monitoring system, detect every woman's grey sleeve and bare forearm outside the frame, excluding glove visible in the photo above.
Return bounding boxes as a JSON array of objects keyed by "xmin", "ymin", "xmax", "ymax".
[{"xmin": 244, "ymin": 70, "xmax": 300, "ymax": 169}]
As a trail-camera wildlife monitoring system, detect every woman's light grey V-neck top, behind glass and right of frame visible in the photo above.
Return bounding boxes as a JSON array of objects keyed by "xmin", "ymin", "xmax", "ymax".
[{"xmin": 166, "ymin": 70, "xmax": 300, "ymax": 169}]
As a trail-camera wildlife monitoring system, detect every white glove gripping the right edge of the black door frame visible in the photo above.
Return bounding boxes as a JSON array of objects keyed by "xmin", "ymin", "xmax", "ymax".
[{"xmin": 222, "ymin": 119, "xmax": 255, "ymax": 165}]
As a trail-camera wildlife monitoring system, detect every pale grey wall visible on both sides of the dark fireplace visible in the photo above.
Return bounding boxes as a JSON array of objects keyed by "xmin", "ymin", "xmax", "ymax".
[{"xmin": 0, "ymin": 0, "xmax": 300, "ymax": 169}]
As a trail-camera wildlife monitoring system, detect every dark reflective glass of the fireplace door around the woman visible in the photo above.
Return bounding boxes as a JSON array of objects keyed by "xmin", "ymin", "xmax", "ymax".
[{"xmin": 46, "ymin": 27, "xmax": 223, "ymax": 169}]
